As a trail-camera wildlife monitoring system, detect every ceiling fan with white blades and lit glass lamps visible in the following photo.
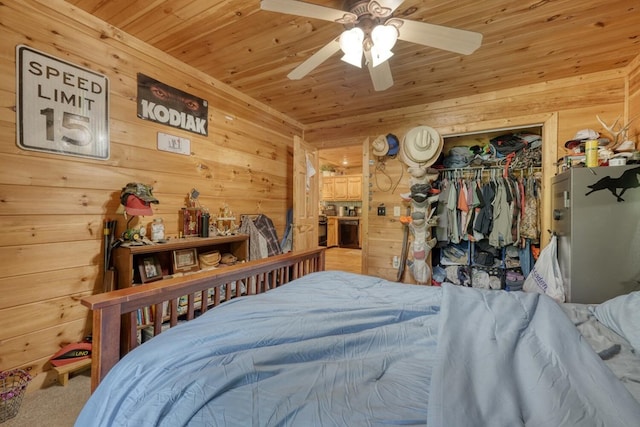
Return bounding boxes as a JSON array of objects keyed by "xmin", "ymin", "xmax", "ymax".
[{"xmin": 260, "ymin": 0, "xmax": 482, "ymax": 91}]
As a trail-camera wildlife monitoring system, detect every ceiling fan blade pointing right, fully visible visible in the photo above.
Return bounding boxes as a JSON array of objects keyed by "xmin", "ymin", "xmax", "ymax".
[{"xmin": 398, "ymin": 19, "xmax": 482, "ymax": 55}]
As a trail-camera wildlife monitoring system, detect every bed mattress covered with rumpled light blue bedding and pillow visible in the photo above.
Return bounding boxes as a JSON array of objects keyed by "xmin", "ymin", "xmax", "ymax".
[{"xmin": 76, "ymin": 249, "xmax": 640, "ymax": 427}]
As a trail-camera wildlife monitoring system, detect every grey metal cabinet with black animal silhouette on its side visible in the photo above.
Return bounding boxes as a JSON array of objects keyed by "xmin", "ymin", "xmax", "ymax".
[{"xmin": 551, "ymin": 164, "xmax": 640, "ymax": 304}]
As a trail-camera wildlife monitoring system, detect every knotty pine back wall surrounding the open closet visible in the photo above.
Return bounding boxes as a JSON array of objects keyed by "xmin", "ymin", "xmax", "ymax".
[{"xmin": 305, "ymin": 67, "xmax": 640, "ymax": 282}]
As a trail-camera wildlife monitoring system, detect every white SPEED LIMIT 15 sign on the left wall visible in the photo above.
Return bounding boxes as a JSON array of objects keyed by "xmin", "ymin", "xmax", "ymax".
[{"xmin": 16, "ymin": 45, "xmax": 109, "ymax": 160}]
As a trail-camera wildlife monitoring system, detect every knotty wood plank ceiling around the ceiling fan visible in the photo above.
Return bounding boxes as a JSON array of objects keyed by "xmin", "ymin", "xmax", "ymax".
[{"xmin": 68, "ymin": 0, "xmax": 640, "ymax": 129}]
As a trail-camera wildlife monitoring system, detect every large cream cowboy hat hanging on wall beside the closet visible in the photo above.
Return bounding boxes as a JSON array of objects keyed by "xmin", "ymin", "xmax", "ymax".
[{"xmin": 401, "ymin": 126, "xmax": 444, "ymax": 167}]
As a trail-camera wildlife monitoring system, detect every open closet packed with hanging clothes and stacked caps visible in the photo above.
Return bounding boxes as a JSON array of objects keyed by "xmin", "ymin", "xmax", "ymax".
[{"xmin": 431, "ymin": 124, "xmax": 544, "ymax": 290}]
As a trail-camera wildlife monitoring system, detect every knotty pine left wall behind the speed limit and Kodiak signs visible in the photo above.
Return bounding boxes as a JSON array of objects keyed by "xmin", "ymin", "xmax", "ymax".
[{"xmin": 0, "ymin": 0, "xmax": 302, "ymax": 385}]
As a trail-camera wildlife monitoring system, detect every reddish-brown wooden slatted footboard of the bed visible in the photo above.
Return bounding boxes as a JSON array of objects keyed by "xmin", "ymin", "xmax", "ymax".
[{"xmin": 82, "ymin": 247, "xmax": 325, "ymax": 392}]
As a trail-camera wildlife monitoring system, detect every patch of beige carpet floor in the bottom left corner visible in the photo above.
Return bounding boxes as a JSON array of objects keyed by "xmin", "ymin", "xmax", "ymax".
[{"xmin": 0, "ymin": 371, "xmax": 91, "ymax": 427}]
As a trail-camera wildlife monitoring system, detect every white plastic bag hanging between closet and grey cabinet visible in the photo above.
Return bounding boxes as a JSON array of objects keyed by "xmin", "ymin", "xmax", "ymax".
[{"xmin": 522, "ymin": 234, "xmax": 564, "ymax": 302}]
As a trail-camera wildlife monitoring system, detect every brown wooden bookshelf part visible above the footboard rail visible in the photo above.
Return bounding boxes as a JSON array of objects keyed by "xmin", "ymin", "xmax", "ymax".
[{"xmin": 114, "ymin": 234, "xmax": 249, "ymax": 289}]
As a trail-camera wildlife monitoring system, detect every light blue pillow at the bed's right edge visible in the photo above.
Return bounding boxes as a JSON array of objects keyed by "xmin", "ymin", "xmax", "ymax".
[{"xmin": 592, "ymin": 291, "xmax": 640, "ymax": 352}]
